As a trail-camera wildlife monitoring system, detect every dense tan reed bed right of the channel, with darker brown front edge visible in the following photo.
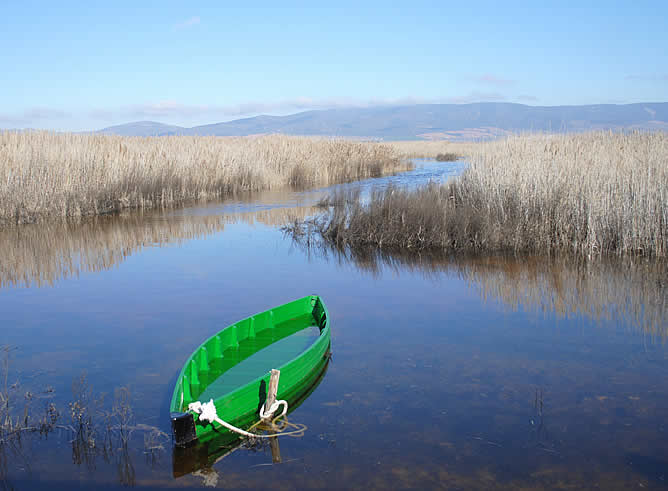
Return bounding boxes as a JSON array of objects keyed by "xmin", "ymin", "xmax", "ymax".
[{"xmin": 298, "ymin": 133, "xmax": 668, "ymax": 257}]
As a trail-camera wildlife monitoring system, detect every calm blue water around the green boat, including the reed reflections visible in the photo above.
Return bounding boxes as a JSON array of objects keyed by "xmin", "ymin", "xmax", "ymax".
[{"xmin": 0, "ymin": 161, "xmax": 668, "ymax": 490}]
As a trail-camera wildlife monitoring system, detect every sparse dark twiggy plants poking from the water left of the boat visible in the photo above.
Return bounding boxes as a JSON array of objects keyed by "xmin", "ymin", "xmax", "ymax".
[{"xmin": 0, "ymin": 345, "xmax": 170, "ymax": 489}]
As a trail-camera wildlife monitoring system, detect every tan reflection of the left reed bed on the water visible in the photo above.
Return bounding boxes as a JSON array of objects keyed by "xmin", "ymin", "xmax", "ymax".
[{"xmin": 0, "ymin": 207, "xmax": 313, "ymax": 289}]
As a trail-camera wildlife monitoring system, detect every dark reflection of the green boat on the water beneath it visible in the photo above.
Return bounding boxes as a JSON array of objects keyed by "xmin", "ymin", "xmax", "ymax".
[{"xmin": 172, "ymin": 362, "xmax": 329, "ymax": 484}]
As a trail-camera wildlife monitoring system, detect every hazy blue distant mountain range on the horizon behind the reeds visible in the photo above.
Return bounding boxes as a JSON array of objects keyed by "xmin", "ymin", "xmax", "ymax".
[{"xmin": 99, "ymin": 102, "xmax": 668, "ymax": 140}]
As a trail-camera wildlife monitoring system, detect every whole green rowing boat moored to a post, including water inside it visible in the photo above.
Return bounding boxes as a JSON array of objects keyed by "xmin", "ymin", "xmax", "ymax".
[{"xmin": 170, "ymin": 295, "xmax": 330, "ymax": 446}]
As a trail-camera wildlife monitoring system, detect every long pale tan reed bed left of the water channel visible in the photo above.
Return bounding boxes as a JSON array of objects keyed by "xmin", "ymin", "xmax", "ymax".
[{"xmin": 0, "ymin": 132, "xmax": 408, "ymax": 225}]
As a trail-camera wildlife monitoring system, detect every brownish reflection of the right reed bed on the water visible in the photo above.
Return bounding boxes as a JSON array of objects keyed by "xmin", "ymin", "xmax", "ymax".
[{"xmin": 283, "ymin": 234, "xmax": 668, "ymax": 340}]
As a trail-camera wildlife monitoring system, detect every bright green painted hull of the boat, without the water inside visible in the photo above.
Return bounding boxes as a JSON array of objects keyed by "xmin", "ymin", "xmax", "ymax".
[{"xmin": 170, "ymin": 295, "xmax": 331, "ymax": 446}]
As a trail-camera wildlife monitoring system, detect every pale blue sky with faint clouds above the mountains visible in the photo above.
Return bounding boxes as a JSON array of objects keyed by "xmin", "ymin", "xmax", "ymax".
[{"xmin": 0, "ymin": 0, "xmax": 668, "ymax": 130}]
